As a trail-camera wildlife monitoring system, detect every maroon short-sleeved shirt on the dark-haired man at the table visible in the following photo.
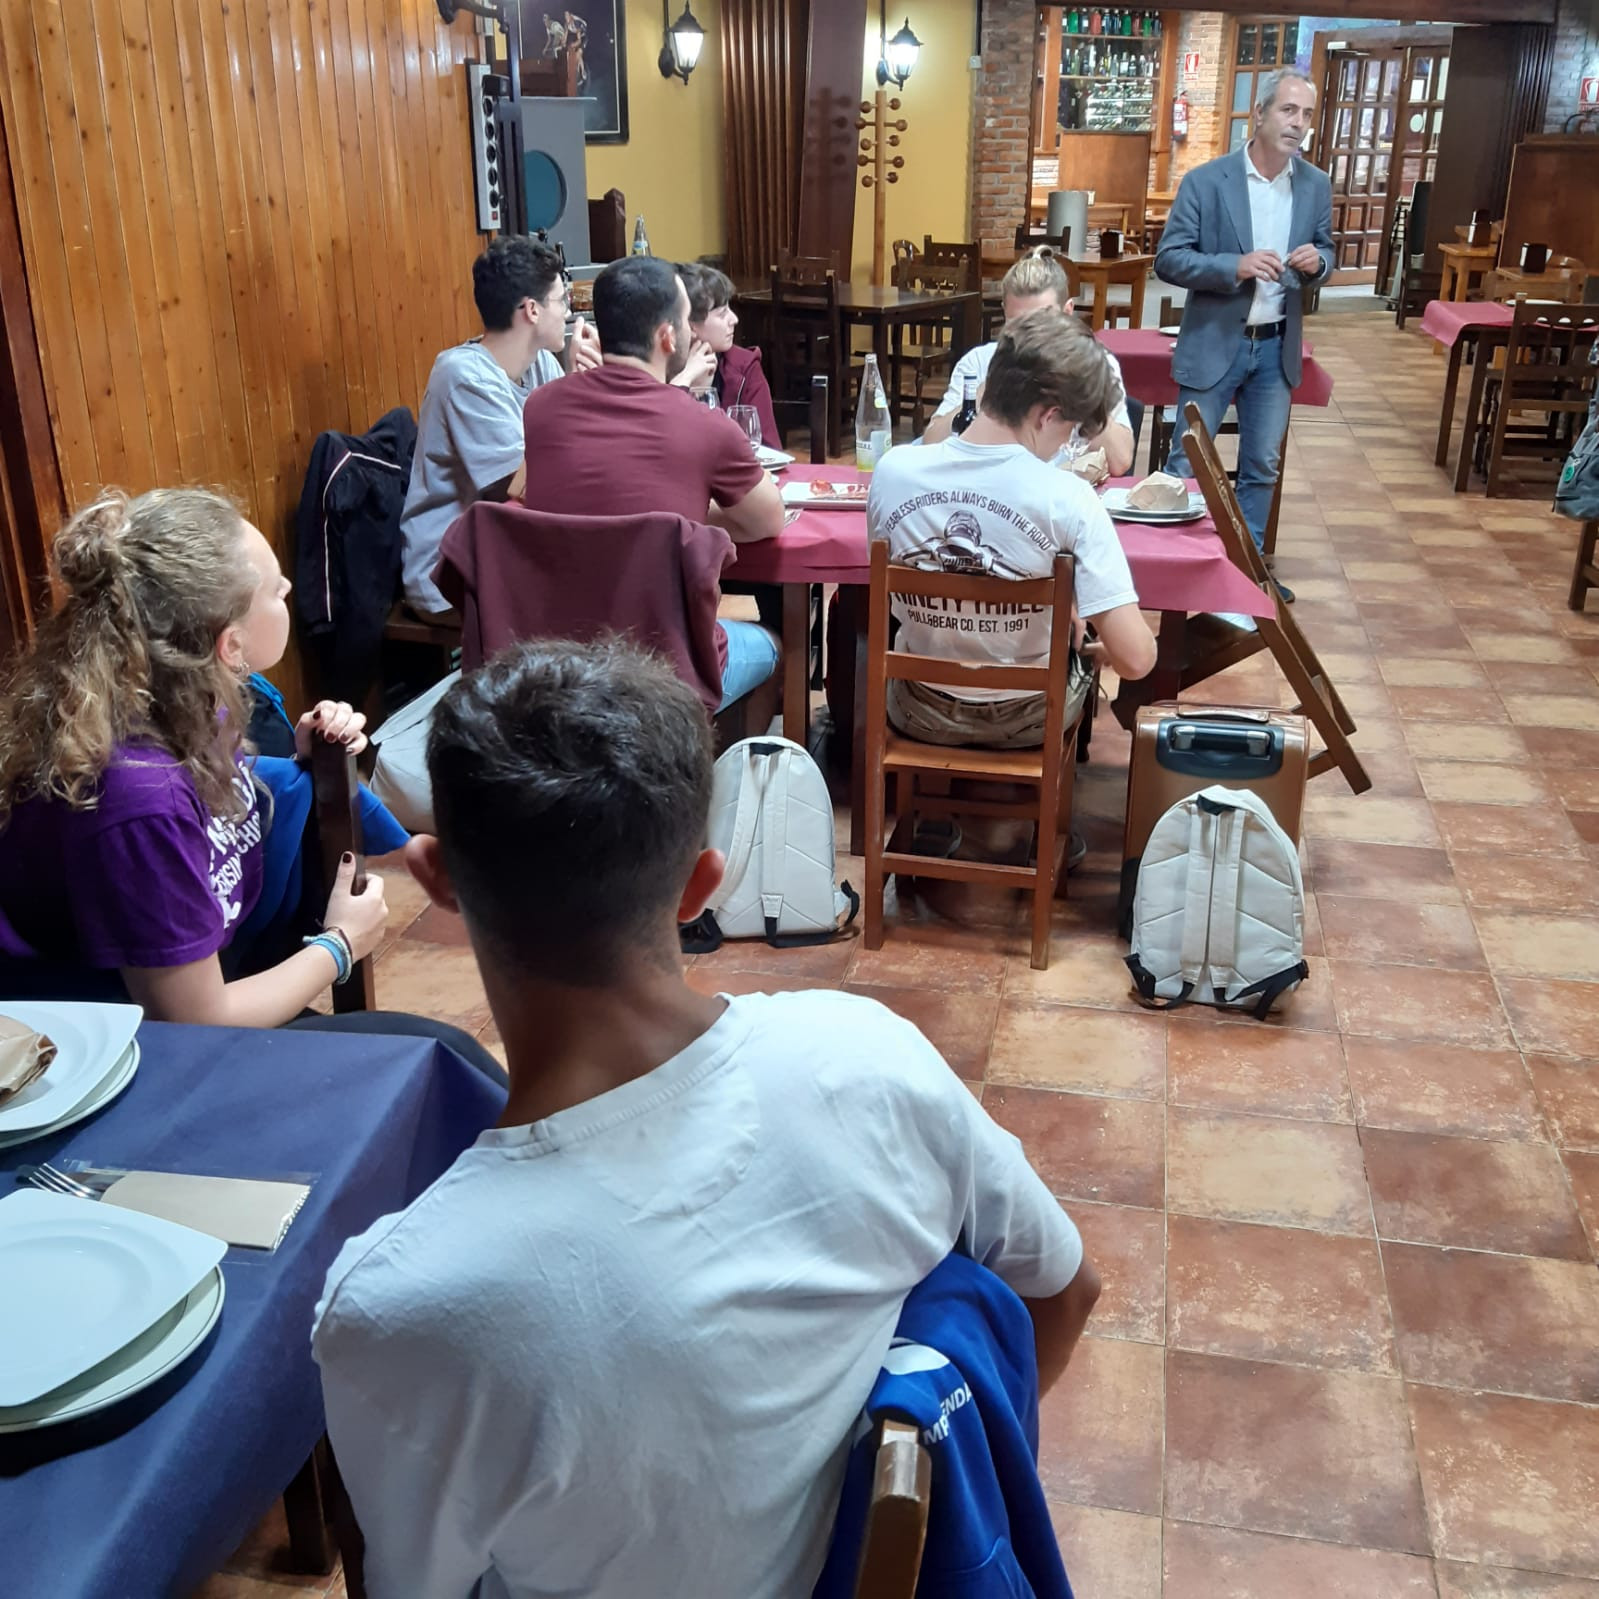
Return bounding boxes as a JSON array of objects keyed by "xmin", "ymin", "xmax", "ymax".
[{"xmin": 521, "ymin": 365, "xmax": 761, "ymax": 521}]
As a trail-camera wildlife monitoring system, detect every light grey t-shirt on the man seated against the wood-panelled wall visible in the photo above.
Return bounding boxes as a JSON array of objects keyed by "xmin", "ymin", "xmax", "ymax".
[{"xmin": 400, "ymin": 339, "xmax": 561, "ymax": 611}]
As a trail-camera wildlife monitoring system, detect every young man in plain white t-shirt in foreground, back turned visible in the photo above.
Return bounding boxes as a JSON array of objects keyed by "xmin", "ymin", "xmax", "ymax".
[{"xmin": 313, "ymin": 641, "xmax": 1099, "ymax": 1599}]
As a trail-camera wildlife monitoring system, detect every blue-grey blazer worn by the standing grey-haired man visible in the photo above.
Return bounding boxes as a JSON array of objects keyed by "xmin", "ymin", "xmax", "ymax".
[{"xmin": 1154, "ymin": 150, "xmax": 1332, "ymax": 389}]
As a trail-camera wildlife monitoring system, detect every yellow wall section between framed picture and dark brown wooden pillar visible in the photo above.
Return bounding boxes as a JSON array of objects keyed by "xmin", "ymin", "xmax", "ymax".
[{"xmin": 587, "ymin": 0, "xmax": 728, "ymax": 261}]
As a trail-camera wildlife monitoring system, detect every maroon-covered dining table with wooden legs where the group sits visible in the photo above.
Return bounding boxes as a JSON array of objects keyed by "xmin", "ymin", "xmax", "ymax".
[{"xmin": 728, "ymin": 462, "xmax": 1276, "ymax": 855}]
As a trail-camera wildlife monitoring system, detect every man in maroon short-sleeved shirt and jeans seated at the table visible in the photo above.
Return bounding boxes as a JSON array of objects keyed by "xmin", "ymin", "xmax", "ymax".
[{"xmin": 521, "ymin": 256, "xmax": 784, "ymax": 705}]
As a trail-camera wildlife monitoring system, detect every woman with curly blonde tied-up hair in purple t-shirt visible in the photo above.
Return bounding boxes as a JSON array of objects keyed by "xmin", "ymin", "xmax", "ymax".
[{"xmin": 0, "ymin": 489, "xmax": 497, "ymax": 1070}]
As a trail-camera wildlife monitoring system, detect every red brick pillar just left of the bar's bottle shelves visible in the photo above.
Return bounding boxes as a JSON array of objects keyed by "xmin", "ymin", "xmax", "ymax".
[{"xmin": 967, "ymin": 0, "xmax": 1038, "ymax": 238}]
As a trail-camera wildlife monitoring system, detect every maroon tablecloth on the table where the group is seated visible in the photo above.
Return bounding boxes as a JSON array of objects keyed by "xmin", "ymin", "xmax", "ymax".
[{"xmin": 728, "ymin": 465, "xmax": 1274, "ymax": 616}]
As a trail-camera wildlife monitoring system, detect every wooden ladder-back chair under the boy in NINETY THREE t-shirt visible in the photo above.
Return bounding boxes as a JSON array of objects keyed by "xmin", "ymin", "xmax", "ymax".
[{"xmin": 865, "ymin": 539, "xmax": 1083, "ymax": 971}]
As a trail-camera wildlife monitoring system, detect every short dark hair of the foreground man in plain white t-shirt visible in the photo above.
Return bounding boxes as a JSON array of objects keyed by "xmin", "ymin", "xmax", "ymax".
[{"xmin": 427, "ymin": 638, "xmax": 712, "ymax": 987}]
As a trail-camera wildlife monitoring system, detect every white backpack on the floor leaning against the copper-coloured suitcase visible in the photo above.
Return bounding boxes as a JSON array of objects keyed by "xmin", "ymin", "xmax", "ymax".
[{"xmin": 1126, "ymin": 785, "xmax": 1310, "ymax": 1019}]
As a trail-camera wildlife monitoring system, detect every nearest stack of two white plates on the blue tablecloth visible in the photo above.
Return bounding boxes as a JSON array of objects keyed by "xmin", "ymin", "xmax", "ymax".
[{"xmin": 0, "ymin": 1188, "xmax": 227, "ymax": 1433}]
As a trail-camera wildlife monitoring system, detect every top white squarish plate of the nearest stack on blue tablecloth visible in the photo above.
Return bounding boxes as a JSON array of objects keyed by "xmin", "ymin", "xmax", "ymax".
[{"xmin": 0, "ymin": 1188, "xmax": 227, "ymax": 1406}]
